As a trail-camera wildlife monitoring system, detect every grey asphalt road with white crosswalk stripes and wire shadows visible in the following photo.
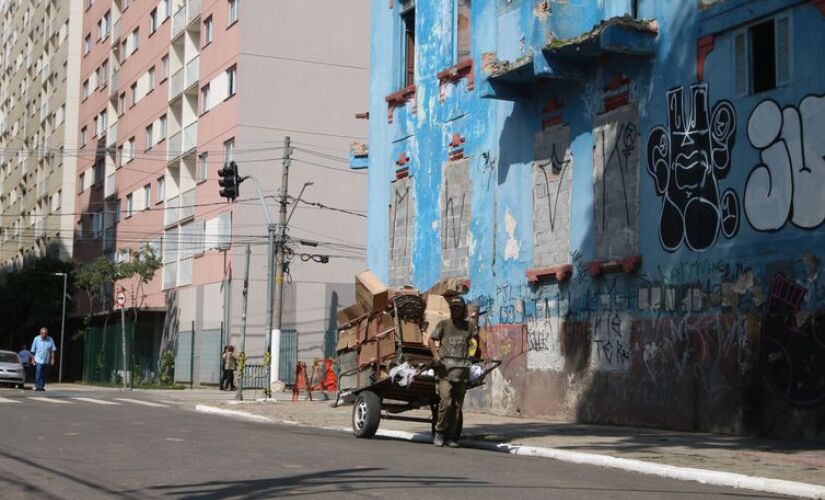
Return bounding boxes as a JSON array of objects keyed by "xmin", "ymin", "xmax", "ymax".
[{"xmin": 0, "ymin": 390, "xmax": 778, "ymax": 500}]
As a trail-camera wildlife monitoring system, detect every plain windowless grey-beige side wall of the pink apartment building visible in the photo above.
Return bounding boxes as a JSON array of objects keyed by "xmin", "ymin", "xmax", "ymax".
[{"xmin": 230, "ymin": 0, "xmax": 370, "ymax": 368}]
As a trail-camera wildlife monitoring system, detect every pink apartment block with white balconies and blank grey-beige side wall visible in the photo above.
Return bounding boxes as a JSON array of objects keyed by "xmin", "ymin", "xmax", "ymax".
[{"xmin": 74, "ymin": 0, "xmax": 369, "ymax": 383}]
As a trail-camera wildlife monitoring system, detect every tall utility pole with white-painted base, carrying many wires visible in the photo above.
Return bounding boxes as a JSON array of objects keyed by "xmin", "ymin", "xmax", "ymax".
[{"xmin": 267, "ymin": 136, "xmax": 292, "ymax": 390}]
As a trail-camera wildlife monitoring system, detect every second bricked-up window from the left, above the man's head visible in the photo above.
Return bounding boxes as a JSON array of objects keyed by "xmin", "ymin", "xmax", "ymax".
[{"xmin": 441, "ymin": 159, "xmax": 473, "ymax": 277}]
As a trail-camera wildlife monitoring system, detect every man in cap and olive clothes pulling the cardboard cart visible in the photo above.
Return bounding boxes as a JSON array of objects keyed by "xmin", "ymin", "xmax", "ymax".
[{"xmin": 429, "ymin": 296, "xmax": 478, "ymax": 448}]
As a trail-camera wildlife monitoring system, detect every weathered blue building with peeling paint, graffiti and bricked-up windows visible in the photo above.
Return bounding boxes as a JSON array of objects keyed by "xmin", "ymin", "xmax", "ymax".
[{"xmin": 368, "ymin": 0, "xmax": 825, "ymax": 439}]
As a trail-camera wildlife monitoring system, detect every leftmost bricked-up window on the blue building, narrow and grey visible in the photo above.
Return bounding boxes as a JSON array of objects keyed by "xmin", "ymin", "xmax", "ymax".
[{"xmin": 389, "ymin": 177, "xmax": 415, "ymax": 285}]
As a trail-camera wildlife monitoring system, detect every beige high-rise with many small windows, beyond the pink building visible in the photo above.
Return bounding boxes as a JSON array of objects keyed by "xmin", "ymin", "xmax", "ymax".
[{"xmin": 0, "ymin": 0, "xmax": 83, "ymax": 270}]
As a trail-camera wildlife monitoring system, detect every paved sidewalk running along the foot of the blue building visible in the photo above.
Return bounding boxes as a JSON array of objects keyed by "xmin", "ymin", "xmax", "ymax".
[{"xmin": 187, "ymin": 398, "xmax": 825, "ymax": 486}]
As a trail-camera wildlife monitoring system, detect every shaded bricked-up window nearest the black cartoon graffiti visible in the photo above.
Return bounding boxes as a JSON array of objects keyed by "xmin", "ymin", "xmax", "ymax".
[{"xmin": 593, "ymin": 105, "xmax": 639, "ymax": 259}]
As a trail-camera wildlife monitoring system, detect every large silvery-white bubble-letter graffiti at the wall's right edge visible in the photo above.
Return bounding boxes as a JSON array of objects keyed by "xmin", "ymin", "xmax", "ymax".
[{"xmin": 745, "ymin": 95, "xmax": 825, "ymax": 231}]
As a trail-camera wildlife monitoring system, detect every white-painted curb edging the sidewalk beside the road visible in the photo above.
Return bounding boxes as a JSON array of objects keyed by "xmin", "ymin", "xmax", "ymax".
[{"xmin": 195, "ymin": 405, "xmax": 825, "ymax": 499}]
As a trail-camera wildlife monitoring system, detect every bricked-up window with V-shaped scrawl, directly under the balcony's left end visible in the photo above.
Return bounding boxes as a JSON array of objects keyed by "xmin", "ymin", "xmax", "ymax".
[{"xmin": 533, "ymin": 125, "xmax": 573, "ymax": 267}]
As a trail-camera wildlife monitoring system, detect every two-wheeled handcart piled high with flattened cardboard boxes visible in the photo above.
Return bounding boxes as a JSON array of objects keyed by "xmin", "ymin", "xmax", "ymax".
[{"xmin": 336, "ymin": 271, "xmax": 500, "ymax": 438}]
